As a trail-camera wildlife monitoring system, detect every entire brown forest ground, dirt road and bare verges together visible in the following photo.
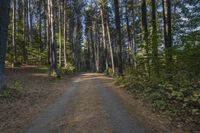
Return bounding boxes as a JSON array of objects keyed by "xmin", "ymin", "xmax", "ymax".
[{"xmin": 0, "ymin": 66, "xmax": 187, "ymax": 133}]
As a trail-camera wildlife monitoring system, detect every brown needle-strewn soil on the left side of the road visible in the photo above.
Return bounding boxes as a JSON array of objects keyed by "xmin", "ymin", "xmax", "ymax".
[{"xmin": 0, "ymin": 66, "xmax": 76, "ymax": 133}]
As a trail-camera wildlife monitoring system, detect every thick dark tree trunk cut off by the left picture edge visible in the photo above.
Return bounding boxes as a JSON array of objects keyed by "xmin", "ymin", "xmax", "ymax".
[{"xmin": 0, "ymin": 0, "xmax": 10, "ymax": 88}]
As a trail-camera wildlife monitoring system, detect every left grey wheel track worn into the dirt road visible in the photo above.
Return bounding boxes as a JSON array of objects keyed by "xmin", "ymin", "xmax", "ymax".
[{"xmin": 25, "ymin": 78, "xmax": 80, "ymax": 133}]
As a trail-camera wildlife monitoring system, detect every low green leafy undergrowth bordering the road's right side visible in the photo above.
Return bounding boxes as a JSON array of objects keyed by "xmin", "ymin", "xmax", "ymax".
[{"xmin": 116, "ymin": 68, "xmax": 200, "ymax": 128}]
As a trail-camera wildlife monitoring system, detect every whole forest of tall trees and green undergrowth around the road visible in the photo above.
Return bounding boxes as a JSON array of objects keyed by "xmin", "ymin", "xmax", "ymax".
[{"xmin": 0, "ymin": 0, "xmax": 200, "ymax": 131}]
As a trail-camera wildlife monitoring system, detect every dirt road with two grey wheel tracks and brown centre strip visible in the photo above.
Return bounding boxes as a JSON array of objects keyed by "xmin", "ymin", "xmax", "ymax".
[{"xmin": 25, "ymin": 73, "xmax": 151, "ymax": 133}]
